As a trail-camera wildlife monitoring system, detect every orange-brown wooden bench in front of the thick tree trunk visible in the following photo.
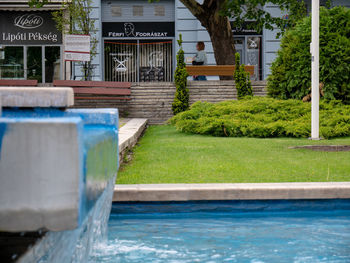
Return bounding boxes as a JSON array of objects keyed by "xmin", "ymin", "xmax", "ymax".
[{"xmin": 186, "ymin": 65, "xmax": 255, "ymax": 76}]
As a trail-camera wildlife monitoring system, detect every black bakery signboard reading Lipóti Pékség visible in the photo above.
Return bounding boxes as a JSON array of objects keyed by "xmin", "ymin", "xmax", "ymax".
[{"xmin": 0, "ymin": 11, "xmax": 62, "ymax": 45}]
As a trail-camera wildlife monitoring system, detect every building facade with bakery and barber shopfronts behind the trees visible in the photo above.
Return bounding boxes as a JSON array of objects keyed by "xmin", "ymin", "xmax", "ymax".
[{"xmin": 0, "ymin": 0, "xmax": 350, "ymax": 83}]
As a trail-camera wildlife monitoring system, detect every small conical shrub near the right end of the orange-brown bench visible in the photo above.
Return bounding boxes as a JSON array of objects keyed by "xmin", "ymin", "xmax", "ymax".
[{"xmin": 233, "ymin": 53, "xmax": 253, "ymax": 99}]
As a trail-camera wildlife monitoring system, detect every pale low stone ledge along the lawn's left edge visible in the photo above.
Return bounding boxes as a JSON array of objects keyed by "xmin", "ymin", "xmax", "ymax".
[{"xmin": 119, "ymin": 119, "xmax": 148, "ymax": 163}]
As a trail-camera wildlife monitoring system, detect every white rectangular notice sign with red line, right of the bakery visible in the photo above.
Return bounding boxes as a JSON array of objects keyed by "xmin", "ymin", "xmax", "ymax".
[{"xmin": 64, "ymin": 35, "xmax": 90, "ymax": 61}]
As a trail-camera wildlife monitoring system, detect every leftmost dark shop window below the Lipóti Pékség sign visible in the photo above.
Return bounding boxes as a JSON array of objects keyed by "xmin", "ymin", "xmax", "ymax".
[{"xmin": 0, "ymin": 47, "xmax": 24, "ymax": 79}]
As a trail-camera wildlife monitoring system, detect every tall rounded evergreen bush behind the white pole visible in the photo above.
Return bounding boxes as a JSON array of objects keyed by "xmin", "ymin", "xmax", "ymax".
[{"xmin": 268, "ymin": 7, "xmax": 350, "ymax": 104}]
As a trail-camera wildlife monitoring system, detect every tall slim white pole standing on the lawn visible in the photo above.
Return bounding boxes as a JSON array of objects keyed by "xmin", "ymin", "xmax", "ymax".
[{"xmin": 311, "ymin": 0, "xmax": 320, "ymax": 140}]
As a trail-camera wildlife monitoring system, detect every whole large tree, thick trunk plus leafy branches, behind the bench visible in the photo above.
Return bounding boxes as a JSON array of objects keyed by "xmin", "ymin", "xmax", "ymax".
[{"xmin": 148, "ymin": 0, "xmax": 312, "ymax": 72}]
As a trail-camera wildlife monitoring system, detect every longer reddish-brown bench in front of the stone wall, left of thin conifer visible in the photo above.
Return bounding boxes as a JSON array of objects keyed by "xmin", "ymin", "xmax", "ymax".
[{"xmin": 53, "ymin": 80, "xmax": 131, "ymax": 100}]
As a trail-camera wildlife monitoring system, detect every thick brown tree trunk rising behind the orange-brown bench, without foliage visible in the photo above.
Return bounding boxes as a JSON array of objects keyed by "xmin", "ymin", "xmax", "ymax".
[{"xmin": 181, "ymin": 0, "xmax": 236, "ymax": 80}]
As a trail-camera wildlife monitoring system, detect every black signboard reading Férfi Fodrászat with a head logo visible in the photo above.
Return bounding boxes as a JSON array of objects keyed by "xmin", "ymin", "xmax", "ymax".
[{"xmin": 102, "ymin": 22, "xmax": 175, "ymax": 38}]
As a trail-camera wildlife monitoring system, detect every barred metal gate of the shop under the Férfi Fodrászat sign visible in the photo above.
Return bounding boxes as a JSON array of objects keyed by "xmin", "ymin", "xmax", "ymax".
[{"xmin": 104, "ymin": 40, "xmax": 173, "ymax": 82}]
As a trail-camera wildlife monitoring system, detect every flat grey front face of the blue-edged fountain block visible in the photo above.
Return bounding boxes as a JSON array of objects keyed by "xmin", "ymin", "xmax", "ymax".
[{"xmin": 0, "ymin": 117, "xmax": 84, "ymax": 232}]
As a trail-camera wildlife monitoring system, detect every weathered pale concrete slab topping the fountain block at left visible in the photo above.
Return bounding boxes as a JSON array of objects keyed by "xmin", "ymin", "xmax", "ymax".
[{"xmin": 0, "ymin": 87, "xmax": 74, "ymax": 107}]
